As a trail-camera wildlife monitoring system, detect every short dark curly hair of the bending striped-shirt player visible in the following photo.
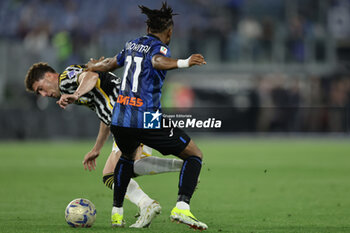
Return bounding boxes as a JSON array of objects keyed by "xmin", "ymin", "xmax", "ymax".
[{"xmin": 24, "ymin": 62, "xmax": 56, "ymax": 92}]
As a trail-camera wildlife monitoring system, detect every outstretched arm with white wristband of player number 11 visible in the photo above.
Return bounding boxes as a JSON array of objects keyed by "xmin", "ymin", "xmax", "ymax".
[{"xmin": 152, "ymin": 54, "xmax": 207, "ymax": 70}]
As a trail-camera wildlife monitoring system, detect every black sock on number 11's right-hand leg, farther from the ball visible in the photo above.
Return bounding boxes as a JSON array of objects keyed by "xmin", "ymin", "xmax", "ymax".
[{"xmin": 178, "ymin": 156, "xmax": 202, "ymax": 204}]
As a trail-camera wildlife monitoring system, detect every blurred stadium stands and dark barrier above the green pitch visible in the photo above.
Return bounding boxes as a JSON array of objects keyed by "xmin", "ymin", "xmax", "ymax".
[{"xmin": 0, "ymin": 0, "xmax": 350, "ymax": 139}]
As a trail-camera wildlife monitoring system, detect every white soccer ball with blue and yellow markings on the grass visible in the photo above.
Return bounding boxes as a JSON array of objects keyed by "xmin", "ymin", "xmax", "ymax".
[{"xmin": 65, "ymin": 198, "xmax": 96, "ymax": 227}]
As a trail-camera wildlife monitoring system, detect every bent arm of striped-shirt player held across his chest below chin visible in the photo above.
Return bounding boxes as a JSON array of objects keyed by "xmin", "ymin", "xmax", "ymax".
[{"xmin": 56, "ymin": 71, "xmax": 98, "ymax": 109}]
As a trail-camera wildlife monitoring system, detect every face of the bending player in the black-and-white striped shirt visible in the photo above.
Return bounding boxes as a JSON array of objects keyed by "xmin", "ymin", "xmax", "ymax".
[{"xmin": 33, "ymin": 73, "xmax": 60, "ymax": 98}]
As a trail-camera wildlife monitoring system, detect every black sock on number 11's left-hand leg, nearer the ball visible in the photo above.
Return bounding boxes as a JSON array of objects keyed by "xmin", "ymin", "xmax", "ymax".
[{"xmin": 113, "ymin": 157, "xmax": 134, "ymax": 207}]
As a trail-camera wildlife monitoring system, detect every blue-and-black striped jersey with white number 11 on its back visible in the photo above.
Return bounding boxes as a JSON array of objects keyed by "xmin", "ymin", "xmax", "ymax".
[{"xmin": 112, "ymin": 35, "xmax": 170, "ymax": 128}]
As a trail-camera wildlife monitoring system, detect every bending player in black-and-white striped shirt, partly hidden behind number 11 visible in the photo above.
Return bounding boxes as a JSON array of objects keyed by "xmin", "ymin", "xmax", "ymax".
[{"xmin": 25, "ymin": 63, "xmax": 182, "ymax": 228}]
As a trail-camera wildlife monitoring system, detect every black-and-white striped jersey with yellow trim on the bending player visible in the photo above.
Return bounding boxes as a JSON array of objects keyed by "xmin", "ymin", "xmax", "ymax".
[{"xmin": 59, "ymin": 65, "xmax": 121, "ymax": 125}]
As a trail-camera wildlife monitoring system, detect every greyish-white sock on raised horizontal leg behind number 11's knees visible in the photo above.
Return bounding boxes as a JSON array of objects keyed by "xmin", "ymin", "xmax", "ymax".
[{"xmin": 134, "ymin": 156, "xmax": 183, "ymax": 176}]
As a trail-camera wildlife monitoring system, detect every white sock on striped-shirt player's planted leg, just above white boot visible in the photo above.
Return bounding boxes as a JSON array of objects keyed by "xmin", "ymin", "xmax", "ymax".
[{"xmin": 125, "ymin": 179, "xmax": 153, "ymax": 208}]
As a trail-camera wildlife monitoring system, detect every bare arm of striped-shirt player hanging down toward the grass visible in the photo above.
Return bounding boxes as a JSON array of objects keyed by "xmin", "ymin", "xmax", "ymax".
[{"xmin": 83, "ymin": 121, "xmax": 109, "ymax": 171}]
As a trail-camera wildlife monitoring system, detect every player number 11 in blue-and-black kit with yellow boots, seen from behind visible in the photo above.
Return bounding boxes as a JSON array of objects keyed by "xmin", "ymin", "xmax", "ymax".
[{"xmin": 89, "ymin": 3, "xmax": 208, "ymax": 230}]
